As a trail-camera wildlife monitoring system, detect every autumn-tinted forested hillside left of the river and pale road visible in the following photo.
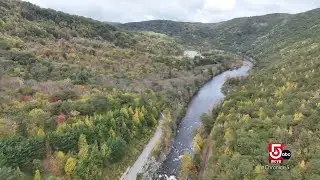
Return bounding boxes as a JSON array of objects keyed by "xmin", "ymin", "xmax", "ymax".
[{"xmin": 0, "ymin": 0, "xmax": 241, "ymax": 180}]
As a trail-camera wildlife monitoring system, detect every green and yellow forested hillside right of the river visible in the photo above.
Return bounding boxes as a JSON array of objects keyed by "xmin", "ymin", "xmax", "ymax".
[{"xmin": 205, "ymin": 9, "xmax": 320, "ymax": 180}]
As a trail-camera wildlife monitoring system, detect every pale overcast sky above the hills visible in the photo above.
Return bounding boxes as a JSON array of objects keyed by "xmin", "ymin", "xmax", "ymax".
[{"xmin": 27, "ymin": 0, "xmax": 320, "ymax": 23}]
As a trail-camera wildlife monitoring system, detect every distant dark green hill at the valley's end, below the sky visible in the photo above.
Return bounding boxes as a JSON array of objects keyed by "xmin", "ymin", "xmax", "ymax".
[{"xmin": 118, "ymin": 14, "xmax": 289, "ymax": 51}]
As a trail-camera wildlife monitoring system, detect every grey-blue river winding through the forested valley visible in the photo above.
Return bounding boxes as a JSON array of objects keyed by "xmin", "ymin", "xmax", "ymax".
[{"xmin": 157, "ymin": 61, "xmax": 252, "ymax": 180}]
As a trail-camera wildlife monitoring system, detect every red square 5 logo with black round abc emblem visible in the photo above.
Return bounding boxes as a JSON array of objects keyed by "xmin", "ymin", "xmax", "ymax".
[{"xmin": 268, "ymin": 143, "xmax": 291, "ymax": 164}]
